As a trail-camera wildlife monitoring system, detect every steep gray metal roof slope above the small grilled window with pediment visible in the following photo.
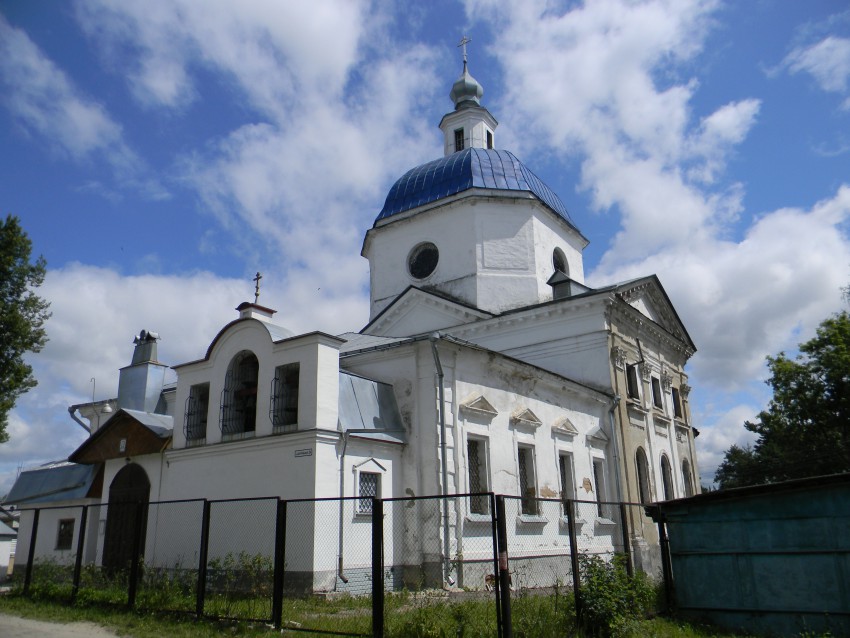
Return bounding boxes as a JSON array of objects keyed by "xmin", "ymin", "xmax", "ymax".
[{"xmin": 339, "ymin": 371, "xmax": 406, "ymax": 443}]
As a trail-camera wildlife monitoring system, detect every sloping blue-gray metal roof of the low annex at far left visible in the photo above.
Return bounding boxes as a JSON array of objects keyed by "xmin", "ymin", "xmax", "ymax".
[{"xmin": 5, "ymin": 463, "xmax": 99, "ymax": 505}]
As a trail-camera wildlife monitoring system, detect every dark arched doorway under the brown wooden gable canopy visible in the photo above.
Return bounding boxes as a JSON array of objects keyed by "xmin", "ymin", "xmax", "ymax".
[{"xmin": 103, "ymin": 463, "xmax": 151, "ymax": 573}]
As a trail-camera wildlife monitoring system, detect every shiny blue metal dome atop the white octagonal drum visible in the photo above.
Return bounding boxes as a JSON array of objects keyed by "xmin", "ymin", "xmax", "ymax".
[{"xmin": 375, "ymin": 148, "xmax": 575, "ymax": 228}]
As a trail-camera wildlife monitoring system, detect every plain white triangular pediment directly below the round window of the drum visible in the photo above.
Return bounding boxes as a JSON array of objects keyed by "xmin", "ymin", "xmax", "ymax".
[{"xmin": 361, "ymin": 287, "xmax": 492, "ymax": 337}]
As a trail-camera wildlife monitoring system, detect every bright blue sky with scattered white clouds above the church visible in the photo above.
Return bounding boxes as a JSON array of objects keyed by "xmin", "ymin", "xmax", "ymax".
[{"xmin": 0, "ymin": 0, "xmax": 850, "ymax": 494}]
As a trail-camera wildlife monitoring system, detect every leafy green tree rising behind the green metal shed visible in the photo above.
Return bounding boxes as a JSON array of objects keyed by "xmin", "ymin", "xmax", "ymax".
[{"xmin": 714, "ymin": 311, "xmax": 850, "ymax": 488}]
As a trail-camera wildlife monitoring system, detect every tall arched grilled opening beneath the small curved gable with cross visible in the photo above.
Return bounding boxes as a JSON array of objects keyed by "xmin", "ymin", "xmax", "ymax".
[{"xmin": 221, "ymin": 350, "xmax": 260, "ymax": 439}]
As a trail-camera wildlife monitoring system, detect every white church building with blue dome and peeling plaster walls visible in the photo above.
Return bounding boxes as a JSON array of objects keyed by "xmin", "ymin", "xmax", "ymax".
[{"xmin": 7, "ymin": 55, "xmax": 699, "ymax": 590}]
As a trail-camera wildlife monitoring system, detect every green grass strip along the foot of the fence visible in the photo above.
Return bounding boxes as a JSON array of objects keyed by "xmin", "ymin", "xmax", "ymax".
[{"xmin": 0, "ymin": 593, "xmax": 768, "ymax": 638}]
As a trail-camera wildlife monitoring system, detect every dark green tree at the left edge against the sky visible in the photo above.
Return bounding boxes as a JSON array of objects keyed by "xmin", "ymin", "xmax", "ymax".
[{"xmin": 0, "ymin": 215, "xmax": 50, "ymax": 443}]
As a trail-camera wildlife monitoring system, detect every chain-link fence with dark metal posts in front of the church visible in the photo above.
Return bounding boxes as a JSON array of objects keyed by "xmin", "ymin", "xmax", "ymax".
[{"xmin": 9, "ymin": 493, "xmax": 671, "ymax": 636}]
